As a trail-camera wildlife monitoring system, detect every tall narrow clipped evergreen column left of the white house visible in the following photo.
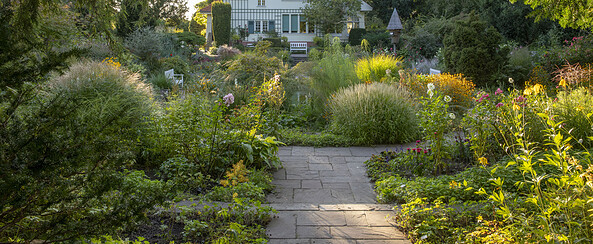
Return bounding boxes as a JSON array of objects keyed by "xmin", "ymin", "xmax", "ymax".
[{"xmin": 212, "ymin": 2, "xmax": 231, "ymax": 46}]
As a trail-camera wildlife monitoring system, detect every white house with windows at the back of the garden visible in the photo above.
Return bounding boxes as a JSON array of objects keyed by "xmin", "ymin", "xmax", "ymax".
[{"xmin": 200, "ymin": 0, "xmax": 372, "ymax": 43}]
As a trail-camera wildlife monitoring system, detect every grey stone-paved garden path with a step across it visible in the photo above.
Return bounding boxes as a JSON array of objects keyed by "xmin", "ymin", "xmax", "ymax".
[{"xmin": 266, "ymin": 146, "xmax": 411, "ymax": 244}]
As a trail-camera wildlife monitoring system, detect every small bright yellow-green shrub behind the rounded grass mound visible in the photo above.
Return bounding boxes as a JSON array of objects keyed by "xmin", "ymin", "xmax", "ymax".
[{"xmin": 356, "ymin": 55, "xmax": 402, "ymax": 82}]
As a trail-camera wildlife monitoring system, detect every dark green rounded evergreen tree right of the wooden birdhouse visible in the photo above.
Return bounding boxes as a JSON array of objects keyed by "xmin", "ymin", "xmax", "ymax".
[{"xmin": 443, "ymin": 14, "xmax": 508, "ymax": 86}]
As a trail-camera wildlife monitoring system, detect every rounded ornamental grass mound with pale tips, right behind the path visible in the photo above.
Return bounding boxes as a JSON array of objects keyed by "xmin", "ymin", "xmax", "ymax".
[{"xmin": 329, "ymin": 83, "xmax": 419, "ymax": 144}]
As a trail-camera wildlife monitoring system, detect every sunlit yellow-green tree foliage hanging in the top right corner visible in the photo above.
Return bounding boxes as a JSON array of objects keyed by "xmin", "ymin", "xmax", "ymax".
[{"xmin": 510, "ymin": 0, "xmax": 593, "ymax": 29}]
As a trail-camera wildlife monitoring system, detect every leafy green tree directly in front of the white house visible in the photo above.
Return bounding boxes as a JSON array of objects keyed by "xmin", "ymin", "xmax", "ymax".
[{"xmin": 302, "ymin": 0, "xmax": 362, "ymax": 34}]
